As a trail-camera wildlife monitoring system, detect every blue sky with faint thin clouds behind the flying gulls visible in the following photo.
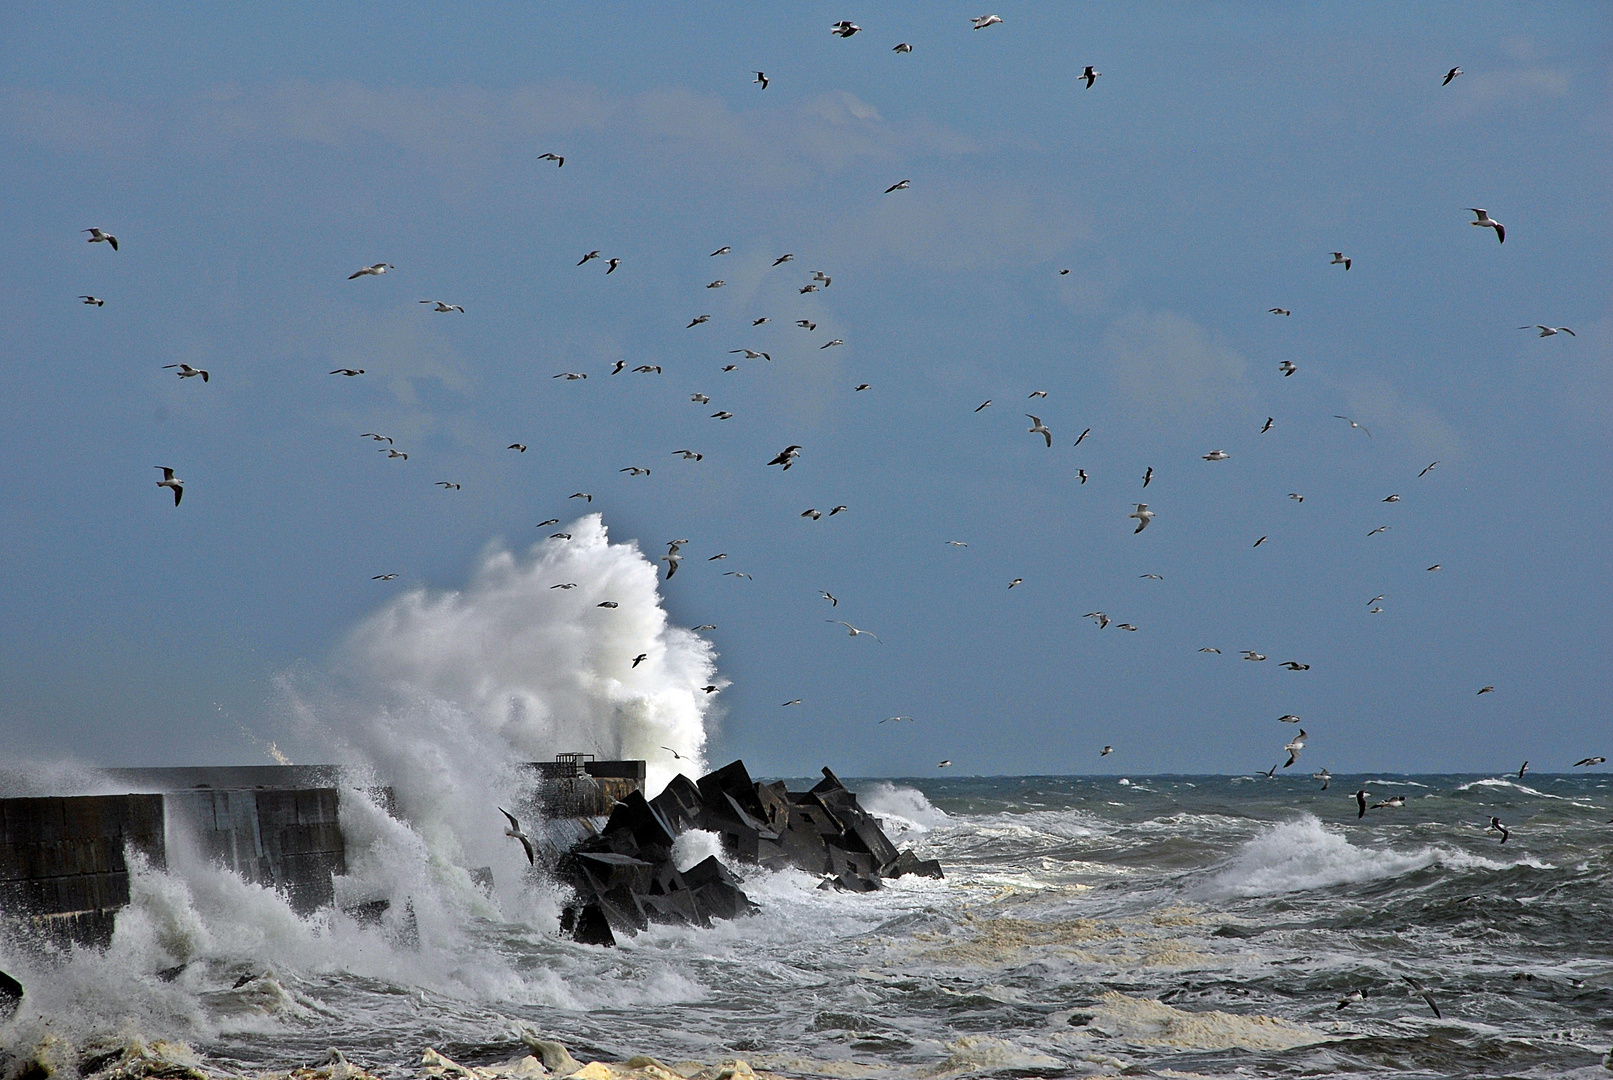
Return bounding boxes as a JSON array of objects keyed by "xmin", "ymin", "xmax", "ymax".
[{"xmin": 0, "ymin": 2, "xmax": 1613, "ymax": 775}]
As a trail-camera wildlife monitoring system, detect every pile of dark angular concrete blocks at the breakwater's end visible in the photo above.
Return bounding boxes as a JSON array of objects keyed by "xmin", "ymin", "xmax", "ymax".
[{"xmin": 555, "ymin": 761, "xmax": 942, "ymax": 945}]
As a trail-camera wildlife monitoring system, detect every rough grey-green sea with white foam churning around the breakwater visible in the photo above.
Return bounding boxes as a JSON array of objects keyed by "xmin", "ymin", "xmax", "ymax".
[{"xmin": 0, "ymin": 762, "xmax": 1613, "ymax": 1078}]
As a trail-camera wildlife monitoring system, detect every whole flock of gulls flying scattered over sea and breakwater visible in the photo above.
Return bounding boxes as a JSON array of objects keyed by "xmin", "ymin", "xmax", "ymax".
[{"xmin": 66, "ymin": 15, "xmax": 1607, "ymax": 838}]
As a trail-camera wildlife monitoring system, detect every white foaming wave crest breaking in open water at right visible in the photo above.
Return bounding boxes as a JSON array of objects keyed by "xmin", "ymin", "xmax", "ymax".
[{"xmin": 1203, "ymin": 814, "xmax": 1507, "ymax": 896}]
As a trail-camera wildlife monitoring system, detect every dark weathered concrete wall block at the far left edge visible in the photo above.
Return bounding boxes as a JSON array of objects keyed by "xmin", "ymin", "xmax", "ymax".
[{"xmin": 0, "ymin": 795, "xmax": 166, "ymax": 945}]
